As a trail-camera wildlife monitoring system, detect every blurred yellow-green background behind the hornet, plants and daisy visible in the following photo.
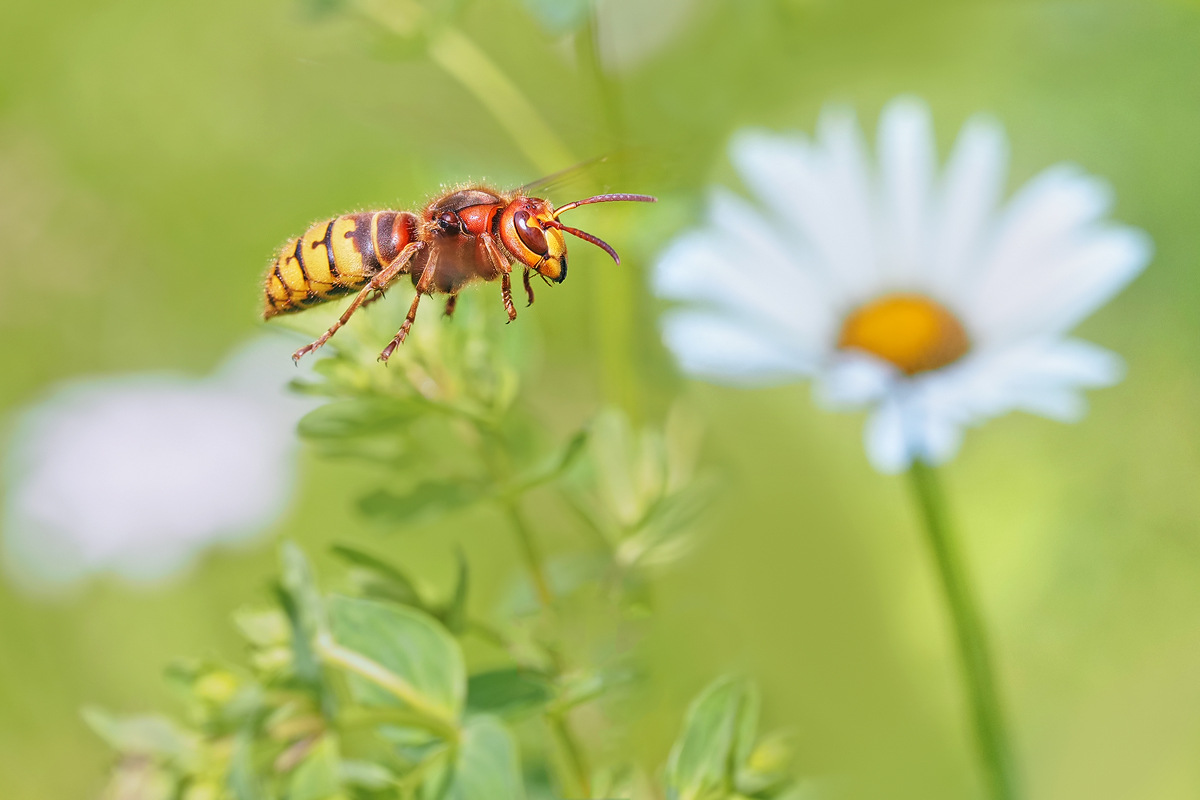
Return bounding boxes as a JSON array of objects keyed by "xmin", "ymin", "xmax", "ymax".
[{"xmin": 0, "ymin": 0, "xmax": 1200, "ymax": 800}]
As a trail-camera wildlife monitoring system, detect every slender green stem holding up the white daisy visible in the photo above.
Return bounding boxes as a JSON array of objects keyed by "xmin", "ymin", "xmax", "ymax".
[{"xmin": 908, "ymin": 461, "xmax": 1018, "ymax": 800}]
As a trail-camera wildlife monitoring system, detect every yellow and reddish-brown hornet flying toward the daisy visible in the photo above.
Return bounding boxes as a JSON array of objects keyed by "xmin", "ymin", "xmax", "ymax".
[{"xmin": 263, "ymin": 186, "xmax": 655, "ymax": 362}]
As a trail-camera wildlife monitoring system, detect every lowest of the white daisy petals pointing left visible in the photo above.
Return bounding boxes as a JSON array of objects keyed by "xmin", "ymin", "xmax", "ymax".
[{"xmin": 662, "ymin": 312, "xmax": 812, "ymax": 386}]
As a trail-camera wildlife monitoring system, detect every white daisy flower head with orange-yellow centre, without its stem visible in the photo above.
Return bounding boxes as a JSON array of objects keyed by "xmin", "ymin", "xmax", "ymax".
[{"xmin": 654, "ymin": 98, "xmax": 1152, "ymax": 473}]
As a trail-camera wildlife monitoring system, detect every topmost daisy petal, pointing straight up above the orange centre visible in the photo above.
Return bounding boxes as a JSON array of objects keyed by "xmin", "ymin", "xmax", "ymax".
[{"xmin": 878, "ymin": 97, "xmax": 937, "ymax": 285}]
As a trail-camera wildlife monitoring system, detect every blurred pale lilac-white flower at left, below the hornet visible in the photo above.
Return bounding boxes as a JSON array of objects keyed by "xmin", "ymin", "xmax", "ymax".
[{"xmin": 4, "ymin": 337, "xmax": 313, "ymax": 589}]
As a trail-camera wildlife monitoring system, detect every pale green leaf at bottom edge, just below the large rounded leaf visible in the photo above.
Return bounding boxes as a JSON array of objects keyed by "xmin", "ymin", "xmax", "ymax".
[{"xmin": 436, "ymin": 716, "xmax": 526, "ymax": 800}]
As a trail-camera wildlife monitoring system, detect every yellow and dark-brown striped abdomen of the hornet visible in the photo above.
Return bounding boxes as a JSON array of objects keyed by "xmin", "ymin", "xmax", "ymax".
[{"xmin": 263, "ymin": 211, "xmax": 416, "ymax": 318}]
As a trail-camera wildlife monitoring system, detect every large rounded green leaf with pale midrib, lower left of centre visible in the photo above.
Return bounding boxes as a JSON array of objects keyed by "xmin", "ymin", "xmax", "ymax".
[{"xmin": 328, "ymin": 595, "xmax": 467, "ymax": 718}]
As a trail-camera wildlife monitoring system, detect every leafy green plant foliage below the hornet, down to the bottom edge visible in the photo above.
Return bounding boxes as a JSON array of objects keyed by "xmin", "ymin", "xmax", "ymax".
[{"xmin": 86, "ymin": 241, "xmax": 786, "ymax": 800}]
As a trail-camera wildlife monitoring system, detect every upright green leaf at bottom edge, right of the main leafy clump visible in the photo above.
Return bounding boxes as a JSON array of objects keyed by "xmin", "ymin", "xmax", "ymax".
[{"xmin": 666, "ymin": 678, "xmax": 758, "ymax": 800}]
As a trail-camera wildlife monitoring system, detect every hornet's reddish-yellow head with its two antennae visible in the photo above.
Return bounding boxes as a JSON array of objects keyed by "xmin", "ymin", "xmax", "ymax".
[{"xmin": 500, "ymin": 194, "xmax": 655, "ymax": 283}]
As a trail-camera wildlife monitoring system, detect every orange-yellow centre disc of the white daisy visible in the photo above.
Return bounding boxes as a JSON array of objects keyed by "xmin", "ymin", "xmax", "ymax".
[{"xmin": 838, "ymin": 294, "xmax": 971, "ymax": 375}]
